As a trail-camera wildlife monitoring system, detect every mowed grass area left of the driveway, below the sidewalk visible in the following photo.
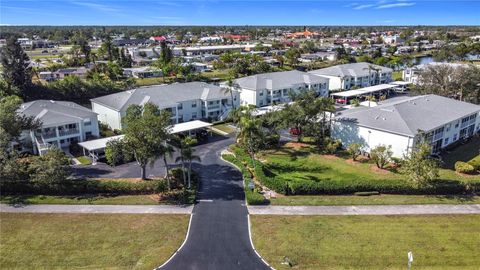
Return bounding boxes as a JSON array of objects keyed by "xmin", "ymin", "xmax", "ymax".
[{"xmin": 0, "ymin": 213, "xmax": 189, "ymax": 270}]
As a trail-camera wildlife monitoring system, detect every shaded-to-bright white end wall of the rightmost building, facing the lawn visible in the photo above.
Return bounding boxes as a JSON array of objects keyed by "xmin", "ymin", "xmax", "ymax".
[{"xmin": 331, "ymin": 122, "xmax": 413, "ymax": 158}]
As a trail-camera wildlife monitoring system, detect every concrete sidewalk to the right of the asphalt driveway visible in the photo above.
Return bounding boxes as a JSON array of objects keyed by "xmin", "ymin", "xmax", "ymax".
[{"xmin": 248, "ymin": 204, "xmax": 480, "ymax": 215}]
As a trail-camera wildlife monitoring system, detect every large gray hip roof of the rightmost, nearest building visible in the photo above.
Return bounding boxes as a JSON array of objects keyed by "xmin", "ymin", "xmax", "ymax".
[{"xmin": 335, "ymin": 95, "xmax": 480, "ymax": 136}]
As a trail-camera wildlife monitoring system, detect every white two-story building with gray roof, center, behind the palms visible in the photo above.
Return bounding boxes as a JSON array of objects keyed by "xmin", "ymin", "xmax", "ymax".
[{"xmin": 234, "ymin": 70, "xmax": 328, "ymax": 107}]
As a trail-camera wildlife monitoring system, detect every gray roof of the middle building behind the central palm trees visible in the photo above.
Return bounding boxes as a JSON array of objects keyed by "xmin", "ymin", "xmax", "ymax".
[{"xmin": 235, "ymin": 70, "xmax": 328, "ymax": 90}]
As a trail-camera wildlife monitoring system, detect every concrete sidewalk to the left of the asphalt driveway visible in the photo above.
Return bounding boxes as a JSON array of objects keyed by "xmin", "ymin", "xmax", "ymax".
[{"xmin": 0, "ymin": 204, "xmax": 193, "ymax": 215}]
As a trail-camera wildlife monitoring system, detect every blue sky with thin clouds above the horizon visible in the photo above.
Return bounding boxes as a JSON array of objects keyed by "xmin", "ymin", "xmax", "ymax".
[{"xmin": 0, "ymin": 0, "xmax": 480, "ymax": 25}]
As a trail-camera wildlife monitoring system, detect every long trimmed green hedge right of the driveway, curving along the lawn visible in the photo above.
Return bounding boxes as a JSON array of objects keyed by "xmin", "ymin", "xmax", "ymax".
[{"xmin": 230, "ymin": 146, "xmax": 480, "ymax": 195}]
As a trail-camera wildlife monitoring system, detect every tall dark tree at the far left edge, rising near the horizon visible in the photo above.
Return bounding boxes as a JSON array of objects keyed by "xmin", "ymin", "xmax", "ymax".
[{"xmin": 0, "ymin": 36, "xmax": 32, "ymax": 98}]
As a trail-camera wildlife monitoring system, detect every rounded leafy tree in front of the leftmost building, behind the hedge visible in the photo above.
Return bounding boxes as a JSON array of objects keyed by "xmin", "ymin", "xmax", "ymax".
[{"xmin": 29, "ymin": 147, "xmax": 70, "ymax": 188}]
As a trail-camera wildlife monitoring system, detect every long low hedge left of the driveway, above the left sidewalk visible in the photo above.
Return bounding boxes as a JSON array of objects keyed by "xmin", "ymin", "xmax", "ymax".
[{"xmin": 0, "ymin": 179, "xmax": 167, "ymax": 195}]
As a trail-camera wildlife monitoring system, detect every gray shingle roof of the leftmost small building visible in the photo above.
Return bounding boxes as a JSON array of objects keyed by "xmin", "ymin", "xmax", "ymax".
[{"xmin": 19, "ymin": 100, "xmax": 97, "ymax": 125}]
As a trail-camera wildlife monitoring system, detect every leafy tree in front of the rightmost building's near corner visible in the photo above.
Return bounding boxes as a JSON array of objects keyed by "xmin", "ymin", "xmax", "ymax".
[{"xmin": 400, "ymin": 143, "xmax": 439, "ymax": 186}]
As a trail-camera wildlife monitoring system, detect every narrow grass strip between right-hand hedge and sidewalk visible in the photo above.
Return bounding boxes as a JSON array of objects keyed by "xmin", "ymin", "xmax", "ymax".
[{"xmin": 270, "ymin": 194, "xmax": 480, "ymax": 206}]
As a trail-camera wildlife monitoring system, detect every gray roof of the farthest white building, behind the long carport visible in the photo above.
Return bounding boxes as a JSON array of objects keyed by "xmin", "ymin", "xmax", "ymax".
[{"xmin": 309, "ymin": 62, "xmax": 393, "ymax": 77}]
